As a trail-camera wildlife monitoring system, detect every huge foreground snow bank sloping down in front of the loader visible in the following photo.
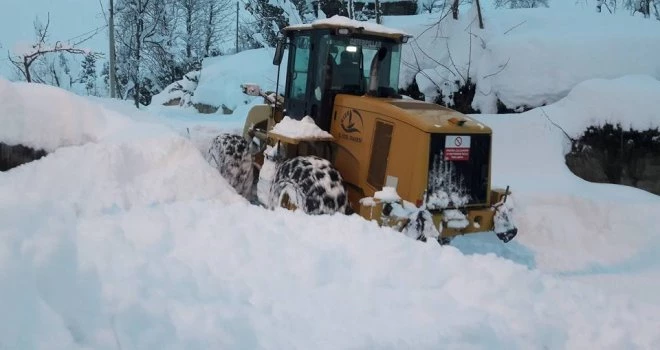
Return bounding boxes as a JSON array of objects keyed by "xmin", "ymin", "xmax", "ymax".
[{"xmin": 0, "ymin": 81, "xmax": 660, "ymax": 349}]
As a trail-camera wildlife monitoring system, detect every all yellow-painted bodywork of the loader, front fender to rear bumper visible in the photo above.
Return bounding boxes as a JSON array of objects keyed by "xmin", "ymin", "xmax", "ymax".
[{"xmin": 251, "ymin": 95, "xmax": 504, "ymax": 237}]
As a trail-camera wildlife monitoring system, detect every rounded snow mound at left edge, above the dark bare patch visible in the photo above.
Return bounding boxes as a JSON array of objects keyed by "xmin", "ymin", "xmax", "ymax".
[{"xmin": 0, "ymin": 79, "xmax": 133, "ymax": 152}]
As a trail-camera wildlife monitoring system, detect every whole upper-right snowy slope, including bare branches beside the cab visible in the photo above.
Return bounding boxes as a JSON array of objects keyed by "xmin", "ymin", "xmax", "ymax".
[{"xmin": 384, "ymin": 7, "xmax": 660, "ymax": 113}]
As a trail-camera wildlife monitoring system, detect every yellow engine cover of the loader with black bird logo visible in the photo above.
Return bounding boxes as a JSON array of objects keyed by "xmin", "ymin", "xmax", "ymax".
[{"xmin": 330, "ymin": 95, "xmax": 491, "ymax": 209}]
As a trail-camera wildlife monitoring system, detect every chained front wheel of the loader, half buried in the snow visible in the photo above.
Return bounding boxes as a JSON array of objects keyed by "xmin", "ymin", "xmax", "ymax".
[{"xmin": 206, "ymin": 134, "xmax": 254, "ymax": 199}]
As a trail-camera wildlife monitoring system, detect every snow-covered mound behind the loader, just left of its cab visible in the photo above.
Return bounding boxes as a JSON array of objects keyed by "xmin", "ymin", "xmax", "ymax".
[{"xmin": 192, "ymin": 48, "xmax": 287, "ymax": 111}]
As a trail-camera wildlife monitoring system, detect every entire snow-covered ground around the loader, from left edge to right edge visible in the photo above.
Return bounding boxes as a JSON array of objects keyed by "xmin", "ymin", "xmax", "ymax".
[{"xmin": 0, "ymin": 69, "xmax": 660, "ymax": 349}]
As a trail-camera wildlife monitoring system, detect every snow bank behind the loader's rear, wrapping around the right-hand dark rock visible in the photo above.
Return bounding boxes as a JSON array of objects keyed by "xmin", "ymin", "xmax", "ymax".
[{"xmin": 476, "ymin": 76, "xmax": 660, "ymax": 274}]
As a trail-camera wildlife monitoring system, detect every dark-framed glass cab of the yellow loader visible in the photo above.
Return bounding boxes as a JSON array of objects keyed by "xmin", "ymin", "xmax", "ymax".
[{"xmin": 274, "ymin": 23, "xmax": 407, "ymax": 131}]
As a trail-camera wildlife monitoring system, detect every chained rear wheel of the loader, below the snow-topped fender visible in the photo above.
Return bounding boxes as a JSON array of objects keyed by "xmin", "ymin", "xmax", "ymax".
[{"xmin": 269, "ymin": 156, "xmax": 350, "ymax": 215}]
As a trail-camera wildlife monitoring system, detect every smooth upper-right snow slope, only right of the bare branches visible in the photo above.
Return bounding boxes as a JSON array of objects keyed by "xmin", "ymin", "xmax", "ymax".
[{"xmin": 473, "ymin": 10, "xmax": 660, "ymax": 113}]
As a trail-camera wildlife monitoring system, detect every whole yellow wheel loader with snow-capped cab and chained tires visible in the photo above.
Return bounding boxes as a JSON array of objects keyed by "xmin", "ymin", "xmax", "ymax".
[{"xmin": 208, "ymin": 16, "xmax": 517, "ymax": 244}]
